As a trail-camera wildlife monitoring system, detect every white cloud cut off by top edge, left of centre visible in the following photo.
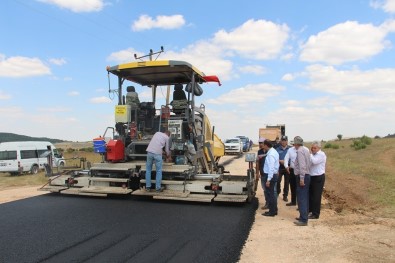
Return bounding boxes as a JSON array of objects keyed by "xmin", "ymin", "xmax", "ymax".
[{"xmin": 37, "ymin": 0, "xmax": 104, "ymax": 13}]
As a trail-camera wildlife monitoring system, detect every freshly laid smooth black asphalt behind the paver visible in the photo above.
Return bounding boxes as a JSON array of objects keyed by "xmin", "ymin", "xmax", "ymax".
[{"xmin": 0, "ymin": 194, "xmax": 257, "ymax": 263}]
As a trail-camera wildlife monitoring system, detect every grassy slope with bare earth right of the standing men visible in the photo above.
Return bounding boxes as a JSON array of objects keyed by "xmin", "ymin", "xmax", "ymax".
[{"xmin": 323, "ymin": 138, "xmax": 395, "ymax": 217}]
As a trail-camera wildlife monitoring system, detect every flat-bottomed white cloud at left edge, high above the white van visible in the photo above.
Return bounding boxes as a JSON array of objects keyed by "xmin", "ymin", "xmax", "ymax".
[{"xmin": 0, "ymin": 54, "xmax": 51, "ymax": 78}]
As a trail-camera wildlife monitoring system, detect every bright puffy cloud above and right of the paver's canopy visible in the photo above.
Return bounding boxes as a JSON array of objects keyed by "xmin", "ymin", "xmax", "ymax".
[{"xmin": 213, "ymin": 19, "xmax": 290, "ymax": 59}]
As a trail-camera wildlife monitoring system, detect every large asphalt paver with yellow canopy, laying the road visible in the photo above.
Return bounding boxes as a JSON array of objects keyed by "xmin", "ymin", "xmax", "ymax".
[{"xmin": 40, "ymin": 54, "xmax": 256, "ymax": 202}]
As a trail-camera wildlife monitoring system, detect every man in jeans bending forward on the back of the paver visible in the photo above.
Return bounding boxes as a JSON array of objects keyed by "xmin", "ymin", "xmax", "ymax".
[{"xmin": 145, "ymin": 131, "xmax": 171, "ymax": 192}]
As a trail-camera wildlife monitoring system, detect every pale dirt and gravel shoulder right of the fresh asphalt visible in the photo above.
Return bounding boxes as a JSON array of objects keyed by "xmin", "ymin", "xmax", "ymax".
[{"xmin": 239, "ymin": 187, "xmax": 395, "ymax": 263}]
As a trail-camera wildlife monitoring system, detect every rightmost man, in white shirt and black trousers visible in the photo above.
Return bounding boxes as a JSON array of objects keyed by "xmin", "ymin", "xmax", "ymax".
[{"xmin": 309, "ymin": 141, "xmax": 326, "ymax": 219}]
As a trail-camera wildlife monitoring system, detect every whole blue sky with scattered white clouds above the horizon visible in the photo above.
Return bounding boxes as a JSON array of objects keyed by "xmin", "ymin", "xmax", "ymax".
[{"xmin": 0, "ymin": 0, "xmax": 395, "ymax": 141}]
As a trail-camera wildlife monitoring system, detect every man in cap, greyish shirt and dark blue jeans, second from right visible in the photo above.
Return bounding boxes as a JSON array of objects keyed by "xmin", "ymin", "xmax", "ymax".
[{"xmin": 294, "ymin": 136, "xmax": 311, "ymax": 226}]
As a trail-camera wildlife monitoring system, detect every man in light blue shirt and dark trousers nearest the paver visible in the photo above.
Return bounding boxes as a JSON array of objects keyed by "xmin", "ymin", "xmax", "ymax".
[{"xmin": 262, "ymin": 139, "xmax": 280, "ymax": 216}]
